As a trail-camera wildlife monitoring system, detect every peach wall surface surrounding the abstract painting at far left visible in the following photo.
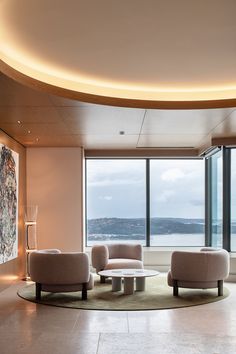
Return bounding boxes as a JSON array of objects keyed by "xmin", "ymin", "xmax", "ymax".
[{"xmin": 0, "ymin": 130, "xmax": 26, "ymax": 291}]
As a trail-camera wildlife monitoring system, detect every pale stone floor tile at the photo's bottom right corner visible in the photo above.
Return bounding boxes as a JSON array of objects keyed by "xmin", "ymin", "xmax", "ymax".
[{"xmin": 97, "ymin": 333, "xmax": 236, "ymax": 354}]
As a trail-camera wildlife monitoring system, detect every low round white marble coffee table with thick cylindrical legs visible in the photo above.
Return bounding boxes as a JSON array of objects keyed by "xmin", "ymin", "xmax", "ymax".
[{"xmin": 98, "ymin": 269, "xmax": 159, "ymax": 295}]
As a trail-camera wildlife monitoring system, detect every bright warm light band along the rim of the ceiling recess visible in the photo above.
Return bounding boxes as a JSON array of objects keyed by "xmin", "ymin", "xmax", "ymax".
[{"xmin": 1, "ymin": 53, "xmax": 236, "ymax": 101}]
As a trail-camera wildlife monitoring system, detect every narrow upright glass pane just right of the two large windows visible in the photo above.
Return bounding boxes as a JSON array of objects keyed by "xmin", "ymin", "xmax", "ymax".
[{"xmin": 211, "ymin": 151, "xmax": 223, "ymax": 248}]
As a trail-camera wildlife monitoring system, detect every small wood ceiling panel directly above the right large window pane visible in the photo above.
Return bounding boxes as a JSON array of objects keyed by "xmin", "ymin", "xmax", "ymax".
[{"xmin": 138, "ymin": 134, "xmax": 205, "ymax": 148}]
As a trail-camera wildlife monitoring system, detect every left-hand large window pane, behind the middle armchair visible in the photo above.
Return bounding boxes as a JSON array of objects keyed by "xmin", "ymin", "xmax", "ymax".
[{"xmin": 86, "ymin": 159, "xmax": 146, "ymax": 246}]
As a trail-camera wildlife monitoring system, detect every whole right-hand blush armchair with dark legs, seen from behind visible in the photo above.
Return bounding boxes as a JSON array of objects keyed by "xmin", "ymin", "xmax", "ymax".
[{"xmin": 167, "ymin": 248, "xmax": 229, "ymax": 296}]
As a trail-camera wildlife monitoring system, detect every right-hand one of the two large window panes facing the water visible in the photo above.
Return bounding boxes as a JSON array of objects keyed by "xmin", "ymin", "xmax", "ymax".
[{"xmin": 150, "ymin": 159, "xmax": 205, "ymax": 246}]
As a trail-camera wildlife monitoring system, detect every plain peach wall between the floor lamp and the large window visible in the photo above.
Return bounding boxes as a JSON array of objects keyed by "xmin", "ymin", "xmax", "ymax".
[{"xmin": 26, "ymin": 148, "xmax": 83, "ymax": 251}]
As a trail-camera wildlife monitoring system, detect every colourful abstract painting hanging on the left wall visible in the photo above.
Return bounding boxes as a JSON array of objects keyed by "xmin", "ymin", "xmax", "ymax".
[{"xmin": 0, "ymin": 144, "xmax": 19, "ymax": 263}]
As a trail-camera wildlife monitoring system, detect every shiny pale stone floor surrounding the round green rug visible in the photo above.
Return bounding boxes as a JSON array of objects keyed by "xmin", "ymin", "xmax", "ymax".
[{"xmin": 0, "ymin": 282, "xmax": 236, "ymax": 354}]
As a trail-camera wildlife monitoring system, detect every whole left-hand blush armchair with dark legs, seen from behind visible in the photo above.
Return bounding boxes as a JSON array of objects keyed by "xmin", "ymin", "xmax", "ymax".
[{"xmin": 30, "ymin": 249, "xmax": 93, "ymax": 299}]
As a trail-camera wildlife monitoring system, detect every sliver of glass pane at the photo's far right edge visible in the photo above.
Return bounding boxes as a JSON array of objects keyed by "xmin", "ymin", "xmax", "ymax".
[{"xmin": 231, "ymin": 149, "xmax": 236, "ymax": 252}]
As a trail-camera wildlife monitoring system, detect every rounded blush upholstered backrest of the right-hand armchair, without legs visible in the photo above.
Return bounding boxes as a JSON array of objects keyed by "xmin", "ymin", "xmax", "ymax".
[{"xmin": 171, "ymin": 249, "xmax": 229, "ymax": 281}]
